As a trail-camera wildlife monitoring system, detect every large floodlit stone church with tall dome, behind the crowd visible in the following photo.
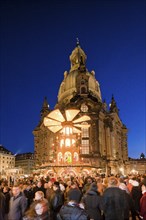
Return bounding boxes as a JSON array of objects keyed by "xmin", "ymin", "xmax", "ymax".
[{"xmin": 33, "ymin": 41, "xmax": 129, "ymax": 175}]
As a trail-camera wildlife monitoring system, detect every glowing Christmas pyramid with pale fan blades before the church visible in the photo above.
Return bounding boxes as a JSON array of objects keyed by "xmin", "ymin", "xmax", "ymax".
[{"xmin": 44, "ymin": 109, "xmax": 90, "ymax": 163}]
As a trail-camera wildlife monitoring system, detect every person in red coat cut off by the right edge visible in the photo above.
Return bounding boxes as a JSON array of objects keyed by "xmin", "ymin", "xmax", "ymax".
[{"xmin": 139, "ymin": 177, "xmax": 146, "ymax": 220}]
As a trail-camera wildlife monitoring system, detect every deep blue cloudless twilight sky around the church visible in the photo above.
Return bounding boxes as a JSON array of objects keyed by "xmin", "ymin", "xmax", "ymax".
[{"xmin": 0, "ymin": 0, "xmax": 146, "ymax": 158}]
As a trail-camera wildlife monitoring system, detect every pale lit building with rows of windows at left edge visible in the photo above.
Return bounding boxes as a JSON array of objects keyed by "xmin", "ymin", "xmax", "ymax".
[{"xmin": 0, "ymin": 145, "xmax": 15, "ymax": 177}]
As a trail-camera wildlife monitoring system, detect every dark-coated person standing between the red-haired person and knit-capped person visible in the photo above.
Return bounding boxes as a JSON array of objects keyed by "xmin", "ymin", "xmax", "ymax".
[{"xmin": 49, "ymin": 181, "xmax": 64, "ymax": 220}]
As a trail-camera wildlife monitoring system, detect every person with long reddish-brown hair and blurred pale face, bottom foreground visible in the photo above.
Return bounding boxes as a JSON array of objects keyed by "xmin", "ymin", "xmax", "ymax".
[{"xmin": 23, "ymin": 200, "xmax": 50, "ymax": 220}]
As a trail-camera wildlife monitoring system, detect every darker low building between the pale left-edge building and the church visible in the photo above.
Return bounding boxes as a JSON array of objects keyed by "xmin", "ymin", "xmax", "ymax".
[{"xmin": 15, "ymin": 152, "xmax": 34, "ymax": 175}]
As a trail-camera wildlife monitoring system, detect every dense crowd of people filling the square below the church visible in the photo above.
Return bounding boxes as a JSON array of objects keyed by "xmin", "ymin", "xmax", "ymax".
[{"xmin": 0, "ymin": 175, "xmax": 146, "ymax": 220}]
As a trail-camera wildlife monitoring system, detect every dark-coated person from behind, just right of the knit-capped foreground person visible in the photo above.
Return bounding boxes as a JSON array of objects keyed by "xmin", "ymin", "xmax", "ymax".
[{"xmin": 82, "ymin": 182, "xmax": 101, "ymax": 220}]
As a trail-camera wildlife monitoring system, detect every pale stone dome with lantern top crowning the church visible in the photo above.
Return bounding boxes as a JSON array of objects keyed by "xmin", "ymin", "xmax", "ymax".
[{"xmin": 58, "ymin": 44, "xmax": 102, "ymax": 104}]
